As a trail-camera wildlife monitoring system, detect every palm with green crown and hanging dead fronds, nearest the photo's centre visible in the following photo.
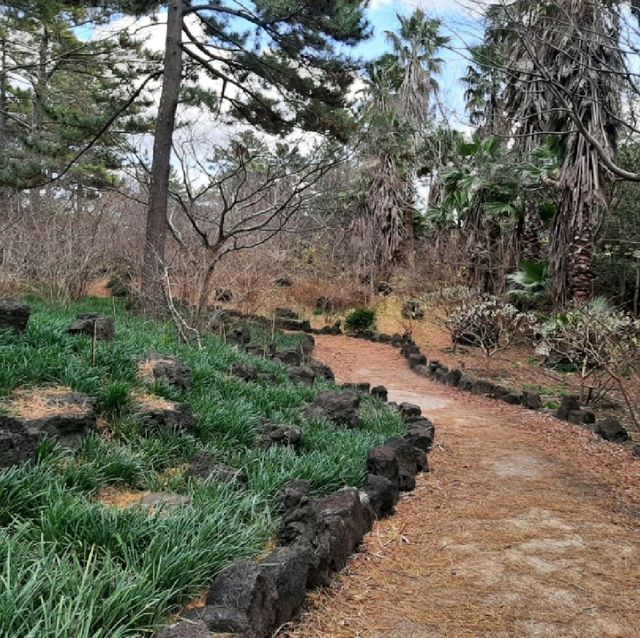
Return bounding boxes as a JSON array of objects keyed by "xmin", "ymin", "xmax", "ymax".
[{"xmin": 353, "ymin": 10, "xmax": 447, "ymax": 278}]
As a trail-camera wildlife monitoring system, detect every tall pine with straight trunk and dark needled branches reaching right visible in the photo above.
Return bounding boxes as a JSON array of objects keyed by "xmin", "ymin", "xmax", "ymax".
[{"xmin": 134, "ymin": 0, "xmax": 376, "ymax": 301}]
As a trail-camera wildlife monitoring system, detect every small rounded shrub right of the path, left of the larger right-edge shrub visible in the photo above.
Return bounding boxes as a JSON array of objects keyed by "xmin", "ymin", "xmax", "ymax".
[{"xmin": 445, "ymin": 295, "xmax": 531, "ymax": 357}]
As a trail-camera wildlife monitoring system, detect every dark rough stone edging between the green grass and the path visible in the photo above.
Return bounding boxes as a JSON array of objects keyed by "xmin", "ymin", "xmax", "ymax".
[{"xmin": 156, "ymin": 368, "xmax": 435, "ymax": 638}]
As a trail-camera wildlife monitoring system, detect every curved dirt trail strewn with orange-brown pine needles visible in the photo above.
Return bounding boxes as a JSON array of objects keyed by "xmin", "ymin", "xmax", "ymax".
[{"xmin": 287, "ymin": 337, "xmax": 640, "ymax": 638}]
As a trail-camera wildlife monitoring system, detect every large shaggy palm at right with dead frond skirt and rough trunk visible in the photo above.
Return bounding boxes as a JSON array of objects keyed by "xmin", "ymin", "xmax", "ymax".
[{"xmin": 495, "ymin": 0, "xmax": 624, "ymax": 304}]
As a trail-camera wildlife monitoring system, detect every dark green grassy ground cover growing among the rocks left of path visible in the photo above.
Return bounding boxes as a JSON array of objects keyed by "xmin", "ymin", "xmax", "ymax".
[{"xmin": 0, "ymin": 301, "xmax": 402, "ymax": 638}]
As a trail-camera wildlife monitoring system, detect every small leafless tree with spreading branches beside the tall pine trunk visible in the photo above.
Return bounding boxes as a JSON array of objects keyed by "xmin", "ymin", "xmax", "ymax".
[{"xmin": 162, "ymin": 129, "xmax": 345, "ymax": 318}]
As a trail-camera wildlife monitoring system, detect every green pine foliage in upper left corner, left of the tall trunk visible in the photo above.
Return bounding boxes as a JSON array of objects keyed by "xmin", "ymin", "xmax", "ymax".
[{"xmin": 0, "ymin": 0, "xmax": 153, "ymax": 191}]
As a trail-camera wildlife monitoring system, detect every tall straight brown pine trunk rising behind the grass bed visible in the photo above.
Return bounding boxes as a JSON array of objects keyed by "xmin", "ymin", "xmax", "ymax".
[{"xmin": 142, "ymin": 0, "xmax": 185, "ymax": 305}]
